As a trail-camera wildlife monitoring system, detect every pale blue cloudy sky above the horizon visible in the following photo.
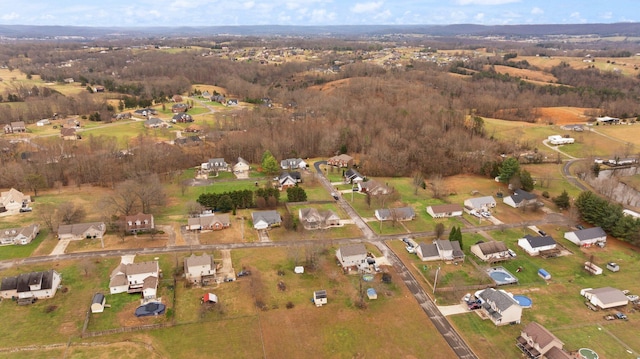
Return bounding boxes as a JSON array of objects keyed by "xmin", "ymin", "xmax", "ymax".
[{"xmin": 0, "ymin": 0, "xmax": 640, "ymax": 27}]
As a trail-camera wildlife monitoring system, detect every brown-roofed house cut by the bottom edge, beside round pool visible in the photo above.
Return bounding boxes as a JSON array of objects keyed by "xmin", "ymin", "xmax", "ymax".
[{"xmin": 516, "ymin": 322, "xmax": 572, "ymax": 359}]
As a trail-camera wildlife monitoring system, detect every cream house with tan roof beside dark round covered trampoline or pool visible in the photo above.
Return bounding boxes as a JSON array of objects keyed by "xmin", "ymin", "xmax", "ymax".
[{"xmin": 109, "ymin": 257, "xmax": 160, "ymax": 300}]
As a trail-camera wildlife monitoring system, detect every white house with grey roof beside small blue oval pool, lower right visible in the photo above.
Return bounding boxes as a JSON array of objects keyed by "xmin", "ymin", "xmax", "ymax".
[{"xmin": 476, "ymin": 288, "xmax": 522, "ymax": 326}]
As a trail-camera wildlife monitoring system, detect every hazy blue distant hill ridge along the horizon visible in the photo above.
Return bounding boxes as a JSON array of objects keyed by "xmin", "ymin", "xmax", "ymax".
[{"xmin": 0, "ymin": 22, "xmax": 640, "ymax": 40}]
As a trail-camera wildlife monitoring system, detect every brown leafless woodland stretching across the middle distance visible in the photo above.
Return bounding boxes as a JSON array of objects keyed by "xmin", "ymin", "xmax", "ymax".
[{"xmin": 0, "ymin": 38, "xmax": 640, "ymax": 189}]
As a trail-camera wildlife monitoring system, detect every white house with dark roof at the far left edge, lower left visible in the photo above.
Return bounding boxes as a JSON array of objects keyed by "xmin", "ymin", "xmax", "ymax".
[{"xmin": 0, "ymin": 269, "xmax": 62, "ymax": 301}]
